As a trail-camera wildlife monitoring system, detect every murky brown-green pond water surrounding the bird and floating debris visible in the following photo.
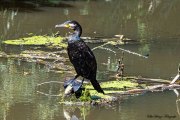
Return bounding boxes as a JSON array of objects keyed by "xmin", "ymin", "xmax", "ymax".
[{"xmin": 0, "ymin": 0, "xmax": 180, "ymax": 120}]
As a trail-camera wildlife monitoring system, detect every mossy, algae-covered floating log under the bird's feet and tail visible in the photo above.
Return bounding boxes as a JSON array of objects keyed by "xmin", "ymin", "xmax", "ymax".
[{"xmin": 60, "ymin": 79, "xmax": 139, "ymax": 105}]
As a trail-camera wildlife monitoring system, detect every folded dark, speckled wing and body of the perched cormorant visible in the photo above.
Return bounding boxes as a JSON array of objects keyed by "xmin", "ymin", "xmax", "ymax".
[{"xmin": 68, "ymin": 41, "xmax": 97, "ymax": 79}]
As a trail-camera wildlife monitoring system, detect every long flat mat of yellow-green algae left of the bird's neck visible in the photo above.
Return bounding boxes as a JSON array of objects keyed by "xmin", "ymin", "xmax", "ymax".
[{"xmin": 3, "ymin": 35, "xmax": 67, "ymax": 48}]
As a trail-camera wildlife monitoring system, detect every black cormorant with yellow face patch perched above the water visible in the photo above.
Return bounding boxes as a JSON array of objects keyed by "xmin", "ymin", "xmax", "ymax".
[{"xmin": 55, "ymin": 20, "xmax": 104, "ymax": 94}]
